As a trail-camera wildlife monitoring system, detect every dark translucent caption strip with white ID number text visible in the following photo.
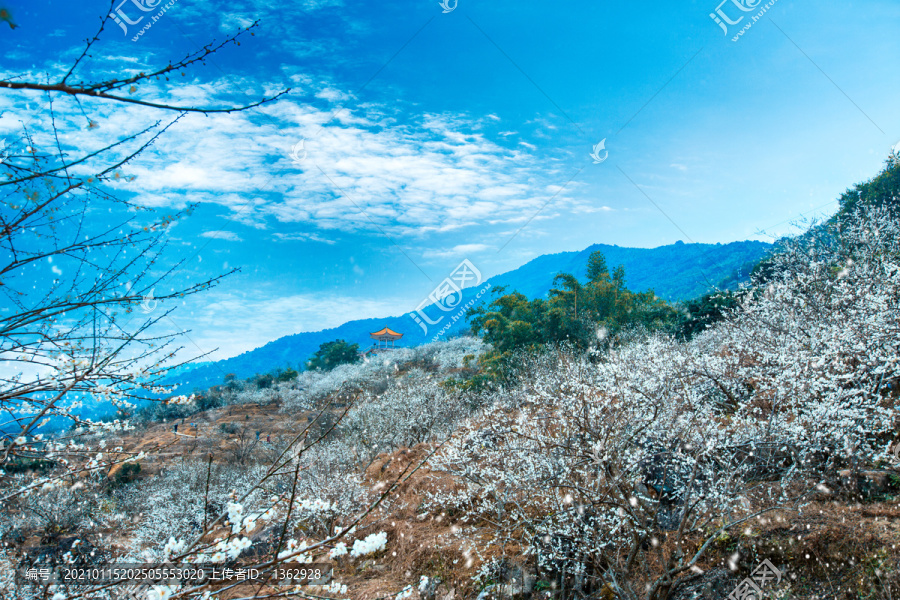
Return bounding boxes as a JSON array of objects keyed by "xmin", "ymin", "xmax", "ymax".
[{"xmin": 16, "ymin": 563, "xmax": 332, "ymax": 585}]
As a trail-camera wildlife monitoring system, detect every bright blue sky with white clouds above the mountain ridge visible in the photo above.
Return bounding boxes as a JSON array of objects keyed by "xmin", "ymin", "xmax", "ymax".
[{"xmin": 0, "ymin": 0, "xmax": 900, "ymax": 357}]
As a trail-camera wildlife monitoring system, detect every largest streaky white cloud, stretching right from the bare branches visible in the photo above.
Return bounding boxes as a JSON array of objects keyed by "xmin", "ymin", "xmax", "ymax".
[{"xmin": 0, "ymin": 65, "xmax": 572, "ymax": 243}]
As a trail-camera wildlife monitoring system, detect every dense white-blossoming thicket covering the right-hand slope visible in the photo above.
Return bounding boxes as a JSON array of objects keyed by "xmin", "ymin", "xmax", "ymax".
[{"xmin": 424, "ymin": 209, "xmax": 900, "ymax": 599}]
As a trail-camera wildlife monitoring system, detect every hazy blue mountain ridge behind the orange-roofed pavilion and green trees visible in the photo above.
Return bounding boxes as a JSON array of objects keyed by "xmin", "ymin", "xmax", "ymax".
[{"xmin": 167, "ymin": 241, "xmax": 771, "ymax": 392}]
